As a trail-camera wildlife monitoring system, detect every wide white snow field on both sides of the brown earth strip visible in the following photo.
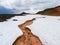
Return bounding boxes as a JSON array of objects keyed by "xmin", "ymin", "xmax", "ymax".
[{"xmin": 0, "ymin": 15, "xmax": 60, "ymax": 45}]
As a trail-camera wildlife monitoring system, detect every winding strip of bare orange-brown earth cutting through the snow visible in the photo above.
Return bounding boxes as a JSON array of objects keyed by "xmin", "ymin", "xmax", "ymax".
[{"xmin": 12, "ymin": 20, "xmax": 43, "ymax": 45}]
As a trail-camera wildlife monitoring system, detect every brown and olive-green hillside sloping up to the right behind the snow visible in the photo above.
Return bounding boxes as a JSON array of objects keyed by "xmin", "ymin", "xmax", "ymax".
[{"xmin": 36, "ymin": 6, "xmax": 60, "ymax": 16}]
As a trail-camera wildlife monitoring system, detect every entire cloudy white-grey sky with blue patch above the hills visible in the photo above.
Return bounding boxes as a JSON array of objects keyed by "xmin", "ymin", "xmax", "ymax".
[{"xmin": 0, "ymin": 0, "xmax": 60, "ymax": 14}]
